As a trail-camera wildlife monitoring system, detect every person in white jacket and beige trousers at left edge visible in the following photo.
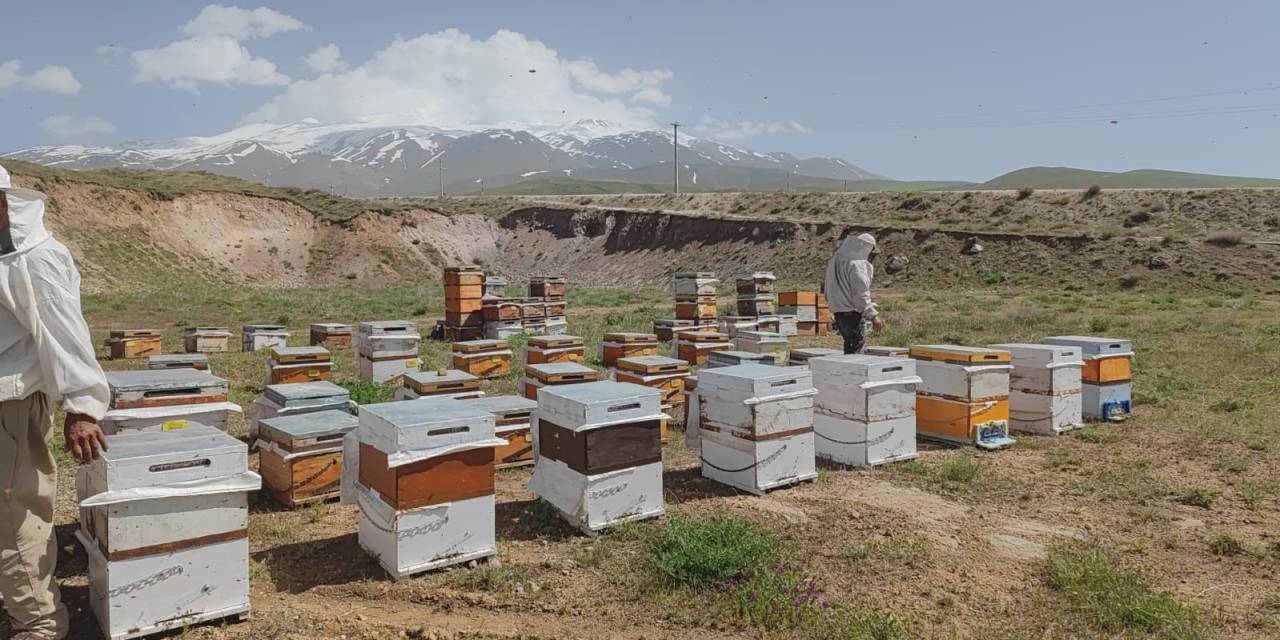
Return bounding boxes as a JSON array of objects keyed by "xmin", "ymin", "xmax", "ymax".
[{"xmin": 0, "ymin": 166, "xmax": 111, "ymax": 640}]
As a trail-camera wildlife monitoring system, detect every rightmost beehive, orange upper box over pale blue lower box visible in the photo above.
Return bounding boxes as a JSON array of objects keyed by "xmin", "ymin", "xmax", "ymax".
[{"xmin": 1044, "ymin": 335, "xmax": 1133, "ymax": 420}]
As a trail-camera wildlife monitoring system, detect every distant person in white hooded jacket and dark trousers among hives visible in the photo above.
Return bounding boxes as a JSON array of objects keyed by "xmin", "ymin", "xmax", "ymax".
[{"xmin": 823, "ymin": 233, "xmax": 884, "ymax": 353}]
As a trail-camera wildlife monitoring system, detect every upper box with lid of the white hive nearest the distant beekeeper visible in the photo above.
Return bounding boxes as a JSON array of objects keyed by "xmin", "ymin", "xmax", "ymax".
[{"xmin": 809, "ymin": 355, "xmax": 920, "ymax": 422}]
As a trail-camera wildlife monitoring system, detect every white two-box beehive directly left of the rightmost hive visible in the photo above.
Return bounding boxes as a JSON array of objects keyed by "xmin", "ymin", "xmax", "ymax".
[{"xmin": 991, "ymin": 343, "xmax": 1084, "ymax": 435}]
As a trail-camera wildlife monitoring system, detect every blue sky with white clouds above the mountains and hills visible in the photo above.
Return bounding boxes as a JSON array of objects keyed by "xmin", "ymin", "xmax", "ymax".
[{"xmin": 0, "ymin": 0, "xmax": 1280, "ymax": 180}]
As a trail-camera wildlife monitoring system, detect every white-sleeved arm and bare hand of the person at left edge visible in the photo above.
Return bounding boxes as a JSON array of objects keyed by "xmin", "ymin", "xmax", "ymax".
[{"xmin": 29, "ymin": 247, "xmax": 111, "ymax": 462}]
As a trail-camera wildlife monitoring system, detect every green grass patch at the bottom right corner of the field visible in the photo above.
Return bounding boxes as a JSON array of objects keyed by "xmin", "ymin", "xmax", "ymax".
[{"xmin": 1046, "ymin": 545, "xmax": 1207, "ymax": 640}]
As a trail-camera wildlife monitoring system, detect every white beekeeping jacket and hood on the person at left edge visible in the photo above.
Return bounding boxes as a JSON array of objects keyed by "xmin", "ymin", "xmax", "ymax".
[{"xmin": 0, "ymin": 162, "xmax": 111, "ymax": 420}]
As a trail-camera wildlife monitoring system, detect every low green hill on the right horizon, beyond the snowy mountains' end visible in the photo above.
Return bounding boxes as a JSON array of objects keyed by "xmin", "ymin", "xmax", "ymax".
[{"xmin": 972, "ymin": 166, "xmax": 1280, "ymax": 189}]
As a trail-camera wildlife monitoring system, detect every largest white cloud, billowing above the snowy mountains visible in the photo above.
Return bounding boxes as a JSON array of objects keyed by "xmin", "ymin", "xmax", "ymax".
[{"xmin": 247, "ymin": 29, "xmax": 672, "ymax": 128}]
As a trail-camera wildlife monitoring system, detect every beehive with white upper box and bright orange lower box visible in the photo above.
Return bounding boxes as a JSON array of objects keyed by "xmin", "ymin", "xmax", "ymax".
[{"xmin": 910, "ymin": 344, "xmax": 1014, "ymax": 449}]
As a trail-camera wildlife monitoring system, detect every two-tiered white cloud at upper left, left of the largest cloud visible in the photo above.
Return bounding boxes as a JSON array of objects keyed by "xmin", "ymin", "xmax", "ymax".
[{"xmin": 131, "ymin": 5, "xmax": 307, "ymax": 92}]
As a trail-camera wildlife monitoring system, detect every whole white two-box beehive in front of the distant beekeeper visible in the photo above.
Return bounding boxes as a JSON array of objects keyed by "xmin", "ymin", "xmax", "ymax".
[{"xmin": 808, "ymin": 355, "xmax": 920, "ymax": 467}]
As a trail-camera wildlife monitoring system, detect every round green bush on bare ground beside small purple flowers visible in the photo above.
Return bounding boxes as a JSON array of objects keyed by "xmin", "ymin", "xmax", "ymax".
[{"xmin": 649, "ymin": 515, "xmax": 782, "ymax": 589}]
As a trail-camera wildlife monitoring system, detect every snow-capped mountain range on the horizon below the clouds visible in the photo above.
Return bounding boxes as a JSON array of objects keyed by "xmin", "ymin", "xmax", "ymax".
[{"xmin": 5, "ymin": 119, "xmax": 879, "ymax": 196}]
